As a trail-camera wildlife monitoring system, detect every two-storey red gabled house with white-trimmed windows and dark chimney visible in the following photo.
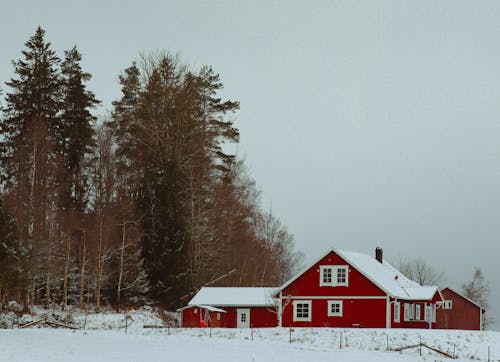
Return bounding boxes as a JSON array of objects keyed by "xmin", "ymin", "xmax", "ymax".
[{"xmin": 275, "ymin": 248, "xmax": 442, "ymax": 328}]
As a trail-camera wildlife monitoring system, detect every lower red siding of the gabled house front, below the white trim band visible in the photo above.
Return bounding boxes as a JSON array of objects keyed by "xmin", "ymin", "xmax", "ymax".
[{"xmin": 282, "ymin": 298, "xmax": 386, "ymax": 328}]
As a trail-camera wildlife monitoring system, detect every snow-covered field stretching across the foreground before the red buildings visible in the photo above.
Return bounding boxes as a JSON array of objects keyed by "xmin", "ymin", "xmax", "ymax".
[{"xmin": 0, "ymin": 310, "xmax": 500, "ymax": 362}]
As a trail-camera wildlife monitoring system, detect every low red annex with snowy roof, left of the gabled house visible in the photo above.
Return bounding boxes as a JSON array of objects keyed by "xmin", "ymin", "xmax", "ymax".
[{"xmin": 179, "ymin": 287, "xmax": 277, "ymax": 328}]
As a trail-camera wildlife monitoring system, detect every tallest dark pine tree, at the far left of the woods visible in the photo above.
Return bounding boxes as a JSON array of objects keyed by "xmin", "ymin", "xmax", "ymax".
[{"xmin": 0, "ymin": 27, "xmax": 61, "ymax": 304}]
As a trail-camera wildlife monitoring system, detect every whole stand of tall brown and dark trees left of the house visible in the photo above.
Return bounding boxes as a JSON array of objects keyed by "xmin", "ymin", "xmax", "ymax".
[{"xmin": 0, "ymin": 27, "xmax": 301, "ymax": 310}]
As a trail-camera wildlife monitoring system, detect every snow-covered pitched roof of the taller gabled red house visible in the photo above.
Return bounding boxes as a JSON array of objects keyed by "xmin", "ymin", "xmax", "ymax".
[{"xmin": 278, "ymin": 249, "xmax": 438, "ymax": 300}]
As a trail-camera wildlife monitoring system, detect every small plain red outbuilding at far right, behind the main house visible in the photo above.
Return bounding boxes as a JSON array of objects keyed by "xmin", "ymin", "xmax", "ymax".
[{"xmin": 437, "ymin": 288, "xmax": 485, "ymax": 330}]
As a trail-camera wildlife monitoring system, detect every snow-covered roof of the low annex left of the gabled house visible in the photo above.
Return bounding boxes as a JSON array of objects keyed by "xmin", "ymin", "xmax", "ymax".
[{"xmin": 188, "ymin": 287, "xmax": 277, "ymax": 307}]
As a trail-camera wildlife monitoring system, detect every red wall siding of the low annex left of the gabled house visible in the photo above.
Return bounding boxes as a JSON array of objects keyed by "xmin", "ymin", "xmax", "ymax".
[{"xmin": 182, "ymin": 306, "xmax": 278, "ymax": 328}]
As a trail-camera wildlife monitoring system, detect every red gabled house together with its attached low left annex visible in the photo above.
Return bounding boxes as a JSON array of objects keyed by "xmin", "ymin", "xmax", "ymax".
[{"xmin": 181, "ymin": 248, "xmax": 442, "ymax": 328}]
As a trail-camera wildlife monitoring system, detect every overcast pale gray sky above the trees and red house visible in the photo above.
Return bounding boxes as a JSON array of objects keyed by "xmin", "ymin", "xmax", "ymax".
[{"xmin": 0, "ymin": 0, "xmax": 500, "ymax": 329}]
